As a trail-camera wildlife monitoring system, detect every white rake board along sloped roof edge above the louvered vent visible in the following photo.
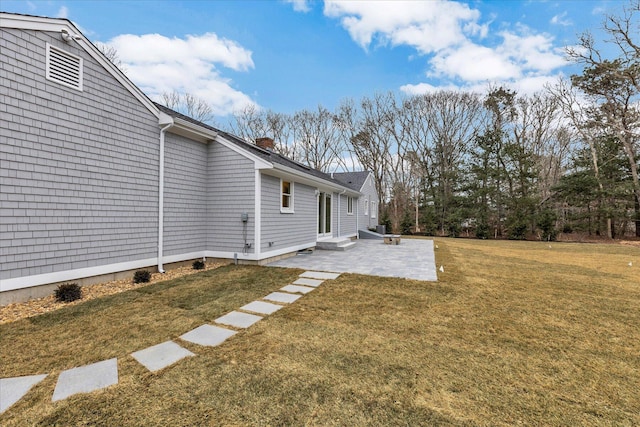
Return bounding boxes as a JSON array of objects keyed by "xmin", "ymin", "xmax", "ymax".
[{"xmin": 0, "ymin": 13, "xmax": 160, "ymax": 117}]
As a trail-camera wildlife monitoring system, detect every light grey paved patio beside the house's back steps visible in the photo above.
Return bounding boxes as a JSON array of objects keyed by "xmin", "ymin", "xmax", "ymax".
[{"xmin": 269, "ymin": 238, "xmax": 438, "ymax": 281}]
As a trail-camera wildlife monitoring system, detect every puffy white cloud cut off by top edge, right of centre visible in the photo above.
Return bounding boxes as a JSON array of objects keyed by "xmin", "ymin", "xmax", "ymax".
[{"xmin": 324, "ymin": 0, "xmax": 486, "ymax": 54}]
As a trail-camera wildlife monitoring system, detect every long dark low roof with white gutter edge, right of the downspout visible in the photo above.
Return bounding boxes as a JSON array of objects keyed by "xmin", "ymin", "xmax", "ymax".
[{"xmin": 155, "ymin": 102, "xmax": 360, "ymax": 194}]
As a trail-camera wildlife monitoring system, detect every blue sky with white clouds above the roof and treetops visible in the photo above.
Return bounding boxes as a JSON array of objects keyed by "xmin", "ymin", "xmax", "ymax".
[{"xmin": 0, "ymin": 0, "xmax": 628, "ymax": 121}]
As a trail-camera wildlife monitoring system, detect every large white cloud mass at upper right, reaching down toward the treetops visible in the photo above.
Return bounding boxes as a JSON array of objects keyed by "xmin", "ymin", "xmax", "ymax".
[{"xmin": 324, "ymin": 0, "xmax": 569, "ymax": 94}]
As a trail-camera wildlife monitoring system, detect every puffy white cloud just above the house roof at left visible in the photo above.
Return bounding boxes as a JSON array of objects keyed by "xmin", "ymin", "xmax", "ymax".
[{"xmin": 106, "ymin": 33, "xmax": 254, "ymax": 116}]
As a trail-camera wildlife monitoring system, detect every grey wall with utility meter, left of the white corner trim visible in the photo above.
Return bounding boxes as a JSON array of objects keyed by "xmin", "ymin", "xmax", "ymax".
[{"xmin": 207, "ymin": 142, "xmax": 256, "ymax": 258}]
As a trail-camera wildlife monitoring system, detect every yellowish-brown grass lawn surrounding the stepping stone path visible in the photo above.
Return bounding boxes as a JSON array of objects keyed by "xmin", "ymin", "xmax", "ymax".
[{"xmin": 0, "ymin": 239, "xmax": 640, "ymax": 426}]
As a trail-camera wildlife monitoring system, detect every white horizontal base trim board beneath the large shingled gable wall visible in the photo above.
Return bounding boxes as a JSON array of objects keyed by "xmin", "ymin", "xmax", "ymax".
[{"xmin": 0, "ymin": 258, "xmax": 158, "ymax": 292}]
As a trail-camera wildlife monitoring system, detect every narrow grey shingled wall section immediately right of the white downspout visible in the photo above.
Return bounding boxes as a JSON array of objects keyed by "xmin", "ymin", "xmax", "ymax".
[{"xmin": 164, "ymin": 133, "xmax": 208, "ymax": 256}]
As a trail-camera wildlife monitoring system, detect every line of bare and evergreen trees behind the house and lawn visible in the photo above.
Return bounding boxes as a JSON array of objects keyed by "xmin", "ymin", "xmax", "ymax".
[{"xmin": 229, "ymin": 0, "xmax": 640, "ymax": 240}]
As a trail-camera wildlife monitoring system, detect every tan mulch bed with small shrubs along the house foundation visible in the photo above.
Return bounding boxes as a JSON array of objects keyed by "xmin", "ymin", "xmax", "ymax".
[{"xmin": 0, "ymin": 262, "xmax": 227, "ymax": 324}]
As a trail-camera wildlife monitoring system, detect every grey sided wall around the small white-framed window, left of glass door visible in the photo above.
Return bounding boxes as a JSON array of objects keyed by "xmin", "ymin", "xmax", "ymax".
[{"xmin": 260, "ymin": 174, "xmax": 318, "ymax": 252}]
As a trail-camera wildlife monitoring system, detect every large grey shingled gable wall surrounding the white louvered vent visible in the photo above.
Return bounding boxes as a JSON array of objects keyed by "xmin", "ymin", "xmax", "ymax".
[{"xmin": 0, "ymin": 28, "xmax": 159, "ymax": 279}]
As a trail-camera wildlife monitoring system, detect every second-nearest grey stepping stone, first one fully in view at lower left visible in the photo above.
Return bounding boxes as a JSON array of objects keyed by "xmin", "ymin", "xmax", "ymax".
[{"xmin": 51, "ymin": 358, "xmax": 118, "ymax": 402}]
